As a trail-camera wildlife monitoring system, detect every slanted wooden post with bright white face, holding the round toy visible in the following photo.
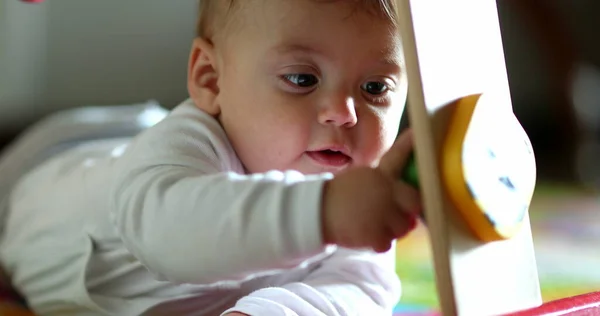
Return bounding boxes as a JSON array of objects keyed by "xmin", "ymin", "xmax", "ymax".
[{"xmin": 396, "ymin": 0, "xmax": 542, "ymax": 316}]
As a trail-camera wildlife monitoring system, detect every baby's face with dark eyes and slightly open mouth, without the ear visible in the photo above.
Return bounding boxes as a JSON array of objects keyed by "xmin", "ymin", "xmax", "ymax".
[{"xmin": 217, "ymin": 0, "xmax": 406, "ymax": 174}]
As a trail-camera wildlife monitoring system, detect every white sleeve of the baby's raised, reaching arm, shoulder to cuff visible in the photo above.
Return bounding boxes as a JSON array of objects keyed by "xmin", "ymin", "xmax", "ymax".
[{"xmin": 109, "ymin": 103, "xmax": 330, "ymax": 284}]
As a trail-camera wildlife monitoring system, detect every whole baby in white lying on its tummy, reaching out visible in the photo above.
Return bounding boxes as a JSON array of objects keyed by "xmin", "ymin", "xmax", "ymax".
[{"xmin": 0, "ymin": 0, "xmax": 421, "ymax": 316}]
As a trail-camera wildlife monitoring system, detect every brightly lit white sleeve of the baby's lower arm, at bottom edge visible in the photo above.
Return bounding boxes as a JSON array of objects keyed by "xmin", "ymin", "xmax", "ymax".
[{"xmin": 222, "ymin": 247, "xmax": 401, "ymax": 316}]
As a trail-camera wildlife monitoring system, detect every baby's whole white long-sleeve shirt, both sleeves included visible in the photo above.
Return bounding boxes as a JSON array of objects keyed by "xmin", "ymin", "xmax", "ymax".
[{"xmin": 0, "ymin": 100, "xmax": 400, "ymax": 316}]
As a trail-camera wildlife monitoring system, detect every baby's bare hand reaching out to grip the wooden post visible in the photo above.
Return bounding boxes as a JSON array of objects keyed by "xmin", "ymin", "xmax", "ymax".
[{"xmin": 322, "ymin": 131, "xmax": 421, "ymax": 252}]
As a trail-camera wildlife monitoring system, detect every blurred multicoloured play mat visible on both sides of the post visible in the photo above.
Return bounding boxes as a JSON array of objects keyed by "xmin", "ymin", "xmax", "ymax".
[{"xmin": 395, "ymin": 184, "xmax": 600, "ymax": 316}]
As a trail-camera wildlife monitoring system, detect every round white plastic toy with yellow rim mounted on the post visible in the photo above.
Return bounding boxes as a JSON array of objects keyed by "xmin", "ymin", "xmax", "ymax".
[{"xmin": 403, "ymin": 94, "xmax": 536, "ymax": 241}]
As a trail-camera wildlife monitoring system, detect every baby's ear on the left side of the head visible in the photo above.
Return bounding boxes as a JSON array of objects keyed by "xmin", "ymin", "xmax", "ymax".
[{"xmin": 187, "ymin": 38, "xmax": 221, "ymax": 116}]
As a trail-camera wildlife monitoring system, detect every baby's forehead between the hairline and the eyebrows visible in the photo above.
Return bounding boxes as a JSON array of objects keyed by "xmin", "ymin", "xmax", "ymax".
[{"xmin": 206, "ymin": 0, "xmax": 404, "ymax": 69}]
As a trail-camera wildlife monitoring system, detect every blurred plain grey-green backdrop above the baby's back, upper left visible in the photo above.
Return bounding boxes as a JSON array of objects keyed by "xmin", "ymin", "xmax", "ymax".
[{"xmin": 0, "ymin": 0, "xmax": 197, "ymax": 147}]
